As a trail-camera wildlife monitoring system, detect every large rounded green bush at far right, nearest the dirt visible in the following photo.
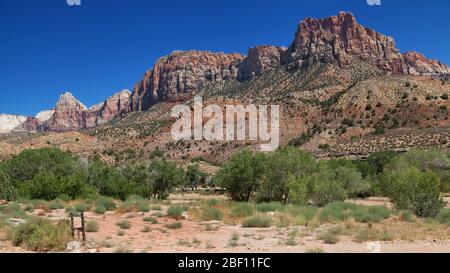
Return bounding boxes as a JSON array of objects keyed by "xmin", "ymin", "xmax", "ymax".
[{"xmin": 388, "ymin": 168, "xmax": 444, "ymax": 217}]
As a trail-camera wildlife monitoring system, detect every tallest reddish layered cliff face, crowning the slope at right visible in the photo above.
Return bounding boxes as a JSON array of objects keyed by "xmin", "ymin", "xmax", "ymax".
[{"xmin": 282, "ymin": 12, "xmax": 449, "ymax": 76}]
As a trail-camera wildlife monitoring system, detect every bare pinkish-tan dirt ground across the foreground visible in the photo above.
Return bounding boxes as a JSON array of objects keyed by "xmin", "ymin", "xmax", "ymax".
[{"xmin": 0, "ymin": 194, "xmax": 450, "ymax": 253}]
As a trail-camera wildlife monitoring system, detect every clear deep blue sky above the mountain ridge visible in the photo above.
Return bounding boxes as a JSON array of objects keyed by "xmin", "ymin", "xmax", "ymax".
[{"xmin": 0, "ymin": 0, "xmax": 450, "ymax": 115}]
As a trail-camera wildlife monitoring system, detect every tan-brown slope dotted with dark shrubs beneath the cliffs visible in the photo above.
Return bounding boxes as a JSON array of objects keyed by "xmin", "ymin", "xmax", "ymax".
[{"xmin": 79, "ymin": 61, "xmax": 450, "ymax": 163}]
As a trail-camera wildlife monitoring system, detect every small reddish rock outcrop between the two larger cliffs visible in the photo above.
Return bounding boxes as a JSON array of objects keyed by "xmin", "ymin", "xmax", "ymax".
[{"xmin": 238, "ymin": 46, "xmax": 287, "ymax": 80}]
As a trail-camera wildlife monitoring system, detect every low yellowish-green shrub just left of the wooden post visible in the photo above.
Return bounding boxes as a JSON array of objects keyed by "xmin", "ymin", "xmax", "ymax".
[{"xmin": 12, "ymin": 219, "xmax": 71, "ymax": 252}]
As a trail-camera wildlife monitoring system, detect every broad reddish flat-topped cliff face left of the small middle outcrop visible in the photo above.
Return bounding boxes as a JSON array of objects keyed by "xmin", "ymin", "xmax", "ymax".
[{"xmin": 131, "ymin": 51, "xmax": 244, "ymax": 111}]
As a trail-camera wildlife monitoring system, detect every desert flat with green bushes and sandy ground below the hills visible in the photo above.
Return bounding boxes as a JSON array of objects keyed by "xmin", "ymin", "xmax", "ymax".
[{"xmin": 0, "ymin": 147, "xmax": 450, "ymax": 253}]
